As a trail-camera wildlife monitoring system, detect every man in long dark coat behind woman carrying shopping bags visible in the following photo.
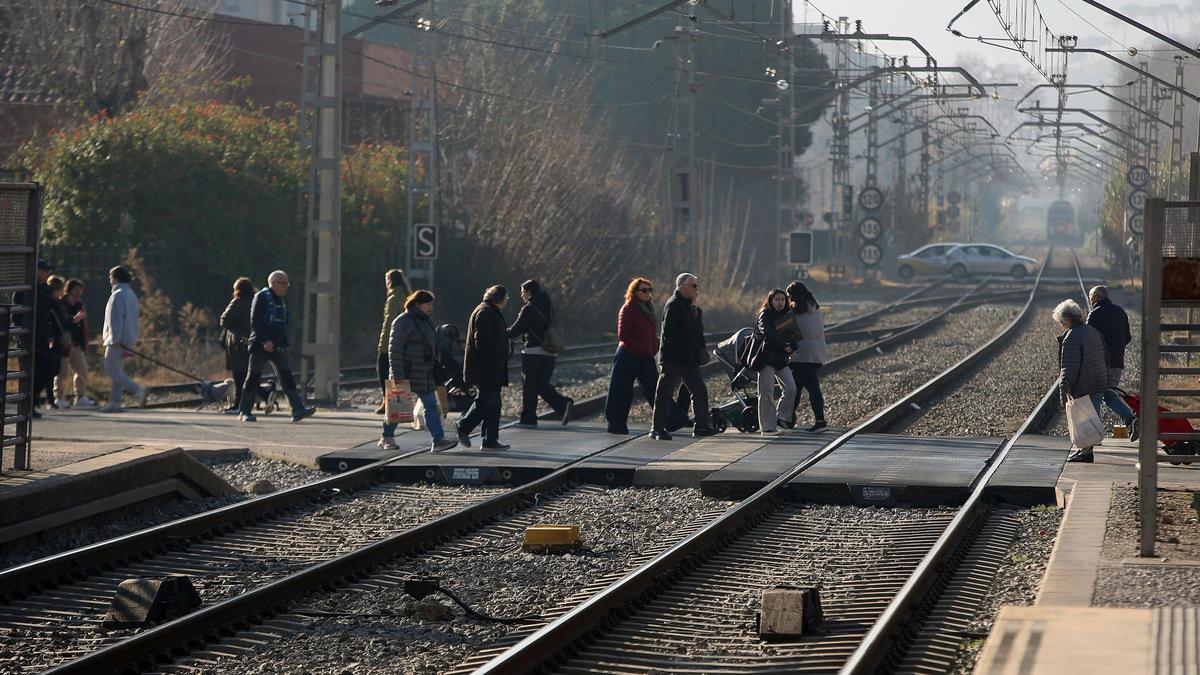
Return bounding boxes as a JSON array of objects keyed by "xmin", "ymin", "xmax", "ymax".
[{"xmin": 455, "ymin": 286, "xmax": 509, "ymax": 450}]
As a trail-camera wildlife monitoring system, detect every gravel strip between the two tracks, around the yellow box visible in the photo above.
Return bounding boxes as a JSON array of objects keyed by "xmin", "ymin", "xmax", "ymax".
[{"xmin": 172, "ymin": 485, "xmax": 730, "ymax": 674}]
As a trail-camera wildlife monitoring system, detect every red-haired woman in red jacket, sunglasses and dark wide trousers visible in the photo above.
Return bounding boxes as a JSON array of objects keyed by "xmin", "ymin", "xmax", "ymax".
[{"xmin": 604, "ymin": 276, "xmax": 659, "ymax": 434}]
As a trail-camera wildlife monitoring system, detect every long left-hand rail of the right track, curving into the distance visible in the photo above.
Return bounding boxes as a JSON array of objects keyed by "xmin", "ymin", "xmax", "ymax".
[{"xmin": 475, "ymin": 250, "xmax": 1052, "ymax": 675}]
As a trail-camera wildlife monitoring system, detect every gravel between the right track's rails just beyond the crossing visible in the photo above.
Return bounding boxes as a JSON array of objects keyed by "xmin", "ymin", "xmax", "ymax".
[{"xmin": 902, "ymin": 300, "xmax": 1058, "ymax": 436}]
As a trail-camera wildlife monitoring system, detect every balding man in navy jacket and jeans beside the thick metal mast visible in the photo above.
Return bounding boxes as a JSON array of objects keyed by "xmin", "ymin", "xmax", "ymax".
[{"xmin": 238, "ymin": 270, "xmax": 317, "ymax": 422}]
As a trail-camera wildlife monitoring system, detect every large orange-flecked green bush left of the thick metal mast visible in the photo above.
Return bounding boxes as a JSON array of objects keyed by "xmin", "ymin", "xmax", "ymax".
[{"xmin": 19, "ymin": 102, "xmax": 302, "ymax": 305}]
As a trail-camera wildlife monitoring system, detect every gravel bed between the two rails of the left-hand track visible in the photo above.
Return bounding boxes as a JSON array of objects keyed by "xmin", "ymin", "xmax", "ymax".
[{"xmin": 0, "ymin": 484, "xmax": 502, "ymax": 673}]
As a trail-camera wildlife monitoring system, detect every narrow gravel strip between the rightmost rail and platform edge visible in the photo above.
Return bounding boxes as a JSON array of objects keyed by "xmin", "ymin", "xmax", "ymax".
[{"xmin": 952, "ymin": 507, "xmax": 1062, "ymax": 675}]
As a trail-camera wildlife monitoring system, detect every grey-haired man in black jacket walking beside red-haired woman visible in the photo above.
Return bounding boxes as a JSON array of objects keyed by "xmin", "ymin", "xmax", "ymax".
[{"xmin": 650, "ymin": 273, "xmax": 716, "ymax": 441}]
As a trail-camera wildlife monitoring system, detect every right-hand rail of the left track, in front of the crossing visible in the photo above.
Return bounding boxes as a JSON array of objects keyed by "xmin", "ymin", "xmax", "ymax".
[{"xmin": 37, "ymin": 436, "xmax": 637, "ymax": 675}]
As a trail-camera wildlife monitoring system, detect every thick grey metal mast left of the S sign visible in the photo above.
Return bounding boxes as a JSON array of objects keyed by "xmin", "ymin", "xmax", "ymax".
[{"xmin": 304, "ymin": 0, "xmax": 342, "ymax": 404}]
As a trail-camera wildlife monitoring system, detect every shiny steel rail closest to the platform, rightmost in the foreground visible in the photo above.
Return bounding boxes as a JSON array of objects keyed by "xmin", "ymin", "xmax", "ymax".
[{"xmin": 840, "ymin": 249, "xmax": 1087, "ymax": 675}]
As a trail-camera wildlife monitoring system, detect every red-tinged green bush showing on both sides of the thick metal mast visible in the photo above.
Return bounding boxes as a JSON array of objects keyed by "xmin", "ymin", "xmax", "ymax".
[{"xmin": 16, "ymin": 102, "xmax": 415, "ymax": 353}]
